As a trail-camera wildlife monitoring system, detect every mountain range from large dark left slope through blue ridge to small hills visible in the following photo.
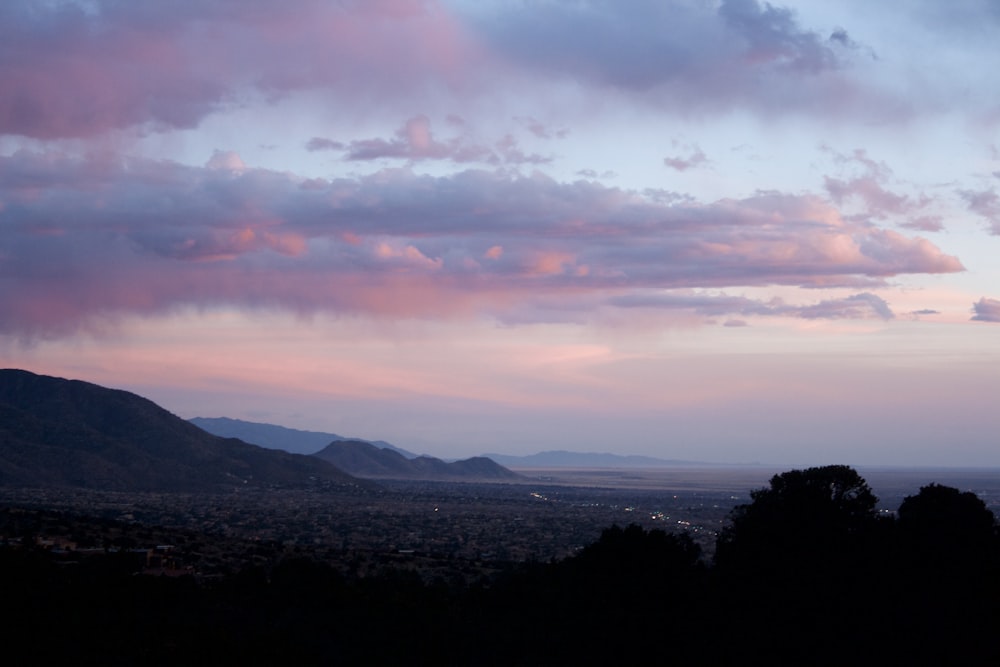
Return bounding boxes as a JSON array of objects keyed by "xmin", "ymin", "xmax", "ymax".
[{"xmin": 0, "ymin": 369, "xmax": 519, "ymax": 492}]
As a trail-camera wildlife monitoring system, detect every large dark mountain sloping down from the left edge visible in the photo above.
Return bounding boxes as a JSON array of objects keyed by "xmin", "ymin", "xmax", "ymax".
[{"xmin": 0, "ymin": 369, "xmax": 369, "ymax": 491}]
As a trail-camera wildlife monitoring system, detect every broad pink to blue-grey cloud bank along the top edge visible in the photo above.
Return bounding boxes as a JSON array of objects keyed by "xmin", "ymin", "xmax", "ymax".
[{"xmin": 0, "ymin": 0, "xmax": 992, "ymax": 144}]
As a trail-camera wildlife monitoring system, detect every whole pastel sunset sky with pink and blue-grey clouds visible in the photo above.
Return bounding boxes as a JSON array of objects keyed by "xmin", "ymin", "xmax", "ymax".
[{"xmin": 0, "ymin": 0, "xmax": 1000, "ymax": 466}]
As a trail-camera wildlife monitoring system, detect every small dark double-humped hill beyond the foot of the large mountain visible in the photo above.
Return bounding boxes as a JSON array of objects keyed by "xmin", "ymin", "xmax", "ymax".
[{"xmin": 314, "ymin": 440, "xmax": 520, "ymax": 480}]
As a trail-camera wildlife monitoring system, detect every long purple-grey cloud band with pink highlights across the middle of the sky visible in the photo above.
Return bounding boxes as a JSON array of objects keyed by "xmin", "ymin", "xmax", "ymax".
[{"xmin": 0, "ymin": 151, "xmax": 962, "ymax": 334}]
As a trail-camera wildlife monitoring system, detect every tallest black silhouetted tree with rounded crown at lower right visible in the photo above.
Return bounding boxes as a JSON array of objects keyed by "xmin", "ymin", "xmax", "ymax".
[{"xmin": 713, "ymin": 465, "xmax": 878, "ymax": 664}]
